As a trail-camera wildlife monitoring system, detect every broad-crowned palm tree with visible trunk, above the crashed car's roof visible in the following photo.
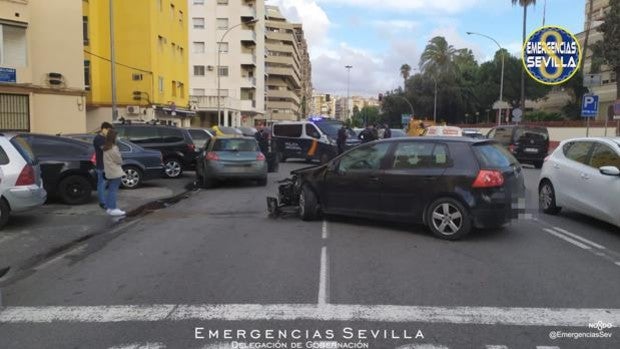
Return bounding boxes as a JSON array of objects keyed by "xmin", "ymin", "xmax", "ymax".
[{"xmin": 420, "ymin": 36, "xmax": 458, "ymax": 122}]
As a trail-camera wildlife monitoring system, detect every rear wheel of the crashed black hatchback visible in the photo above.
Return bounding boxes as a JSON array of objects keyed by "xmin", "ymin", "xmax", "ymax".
[{"xmin": 426, "ymin": 198, "xmax": 472, "ymax": 240}]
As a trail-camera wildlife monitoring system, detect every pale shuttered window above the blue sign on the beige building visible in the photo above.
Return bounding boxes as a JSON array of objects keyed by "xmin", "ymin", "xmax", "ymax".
[{"xmin": 0, "ymin": 24, "xmax": 28, "ymax": 68}]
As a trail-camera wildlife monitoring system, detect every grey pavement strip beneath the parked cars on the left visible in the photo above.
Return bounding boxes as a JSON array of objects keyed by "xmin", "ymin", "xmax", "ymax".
[{"xmin": 0, "ymin": 172, "xmax": 194, "ymax": 280}]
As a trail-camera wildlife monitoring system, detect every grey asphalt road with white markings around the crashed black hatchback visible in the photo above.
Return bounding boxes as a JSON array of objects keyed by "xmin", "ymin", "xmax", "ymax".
[{"xmin": 0, "ymin": 163, "xmax": 620, "ymax": 348}]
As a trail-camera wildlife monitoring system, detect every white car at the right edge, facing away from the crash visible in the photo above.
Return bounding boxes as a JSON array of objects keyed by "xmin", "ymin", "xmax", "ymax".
[{"xmin": 538, "ymin": 138, "xmax": 620, "ymax": 227}]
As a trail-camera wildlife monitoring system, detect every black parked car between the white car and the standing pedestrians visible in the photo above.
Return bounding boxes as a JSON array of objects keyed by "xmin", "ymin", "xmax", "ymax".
[{"xmin": 16, "ymin": 133, "xmax": 97, "ymax": 205}]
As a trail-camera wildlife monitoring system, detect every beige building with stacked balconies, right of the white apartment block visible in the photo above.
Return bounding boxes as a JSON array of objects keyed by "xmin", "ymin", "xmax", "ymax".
[{"xmin": 265, "ymin": 6, "xmax": 312, "ymax": 122}]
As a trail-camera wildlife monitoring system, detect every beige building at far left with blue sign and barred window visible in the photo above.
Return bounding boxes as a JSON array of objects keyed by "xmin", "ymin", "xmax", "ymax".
[{"xmin": 0, "ymin": 0, "xmax": 87, "ymax": 134}]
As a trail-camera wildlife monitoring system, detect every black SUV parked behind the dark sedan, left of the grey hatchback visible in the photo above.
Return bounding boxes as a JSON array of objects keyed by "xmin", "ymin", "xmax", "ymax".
[{"xmin": 114, "ymin": 124, "xmax": 198, "ymax": 178}]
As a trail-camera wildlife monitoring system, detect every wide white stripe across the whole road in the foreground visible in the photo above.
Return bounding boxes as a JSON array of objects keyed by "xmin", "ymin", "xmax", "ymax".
[{"xmin": 0, "ymin": 304, "xmax": 620, "ymax": 327}]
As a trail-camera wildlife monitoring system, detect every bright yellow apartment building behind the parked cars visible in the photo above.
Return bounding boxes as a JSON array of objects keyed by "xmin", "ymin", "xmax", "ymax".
[{"xmin": 82, "ymin": 0, "xmax": 190, "ymax": 129}]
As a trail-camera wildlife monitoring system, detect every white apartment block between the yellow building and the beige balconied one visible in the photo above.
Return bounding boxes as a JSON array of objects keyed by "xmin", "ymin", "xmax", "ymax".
[{"xmin": 189, "ymin": 0, "xmax": 265, "ymax": 127}]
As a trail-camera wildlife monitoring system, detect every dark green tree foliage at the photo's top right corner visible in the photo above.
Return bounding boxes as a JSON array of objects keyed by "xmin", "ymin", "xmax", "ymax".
[{"xmin": 593, "ymin": 0, "xmax": 620, "ymax": 99}]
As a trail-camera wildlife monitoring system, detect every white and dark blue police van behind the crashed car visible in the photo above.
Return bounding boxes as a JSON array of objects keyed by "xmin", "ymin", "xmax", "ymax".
[{"xmin": 271, "ymin": 118, "xmax": 359, "ymax": 164}]
